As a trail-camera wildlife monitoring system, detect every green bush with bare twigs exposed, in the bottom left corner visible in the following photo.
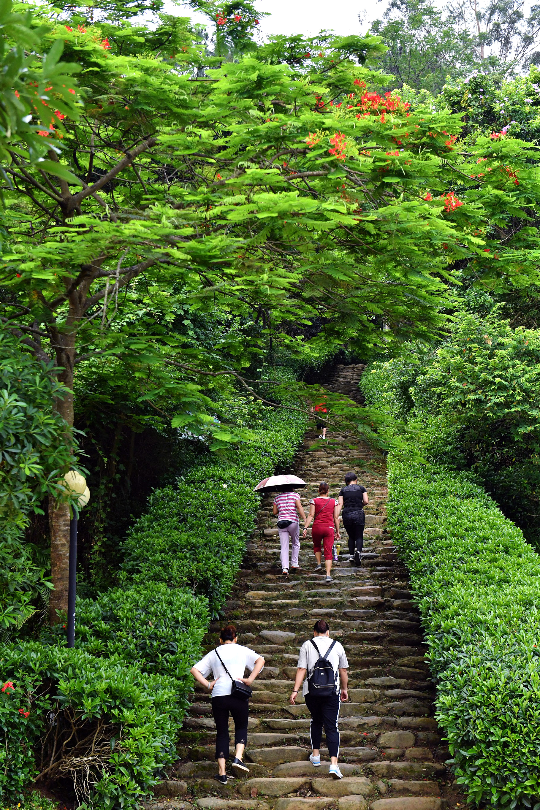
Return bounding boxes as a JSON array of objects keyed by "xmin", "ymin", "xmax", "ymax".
[{"xmin": 0, "ymin": 642, "xmax": 183, "ymax": 810}]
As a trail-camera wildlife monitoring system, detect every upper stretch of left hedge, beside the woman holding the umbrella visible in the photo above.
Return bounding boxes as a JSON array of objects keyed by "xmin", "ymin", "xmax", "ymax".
[{"xmin": 121, "ymin": 376, "xmax": 307, "ymax": 616}]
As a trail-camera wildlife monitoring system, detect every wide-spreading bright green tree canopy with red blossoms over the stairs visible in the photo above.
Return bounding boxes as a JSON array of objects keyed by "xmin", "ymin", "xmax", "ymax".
[{"xmin": 0, "ymin": 2, "xmax": 539, "ymax": 610}]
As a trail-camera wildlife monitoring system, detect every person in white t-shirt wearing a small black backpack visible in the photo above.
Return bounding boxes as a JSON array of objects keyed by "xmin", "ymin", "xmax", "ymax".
[{"xmin": 289, "ymin": 619, "xmax": 349, "ymax": 779}]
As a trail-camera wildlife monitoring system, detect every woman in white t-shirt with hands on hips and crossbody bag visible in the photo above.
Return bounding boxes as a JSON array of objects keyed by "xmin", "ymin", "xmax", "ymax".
[{"xmin": 191, "ymin": 624, "xmax": 264, "ymax": 785}]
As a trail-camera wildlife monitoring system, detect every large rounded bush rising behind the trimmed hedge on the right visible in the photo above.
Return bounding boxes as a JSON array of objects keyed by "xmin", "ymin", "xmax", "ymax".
[{"xmin": 362, "ymin": 308, "xmax": 540, "ymax": 547}]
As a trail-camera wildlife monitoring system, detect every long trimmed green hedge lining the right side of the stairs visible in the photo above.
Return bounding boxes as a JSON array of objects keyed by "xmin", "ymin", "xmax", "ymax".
[{"xmin": 389, "ymin": 456, "xmax": 540, "ymax": 810}]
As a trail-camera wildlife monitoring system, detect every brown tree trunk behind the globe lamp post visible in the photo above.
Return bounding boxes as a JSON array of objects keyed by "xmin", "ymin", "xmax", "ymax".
[{"xmin": 49, "ymin": 312, "xmax": 78, "ymax": 625}]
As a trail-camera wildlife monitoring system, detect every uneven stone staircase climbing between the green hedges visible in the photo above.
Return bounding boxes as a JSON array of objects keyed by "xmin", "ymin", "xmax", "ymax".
[{"xmin": 148, "ymin": 365, "xmax": 466, "ymax": 810}]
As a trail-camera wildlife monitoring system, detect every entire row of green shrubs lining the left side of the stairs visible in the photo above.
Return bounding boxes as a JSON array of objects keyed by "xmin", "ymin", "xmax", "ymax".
[{"xmin": 0, "ymin": 376, "xmax": 307, "ymax": 810}]
